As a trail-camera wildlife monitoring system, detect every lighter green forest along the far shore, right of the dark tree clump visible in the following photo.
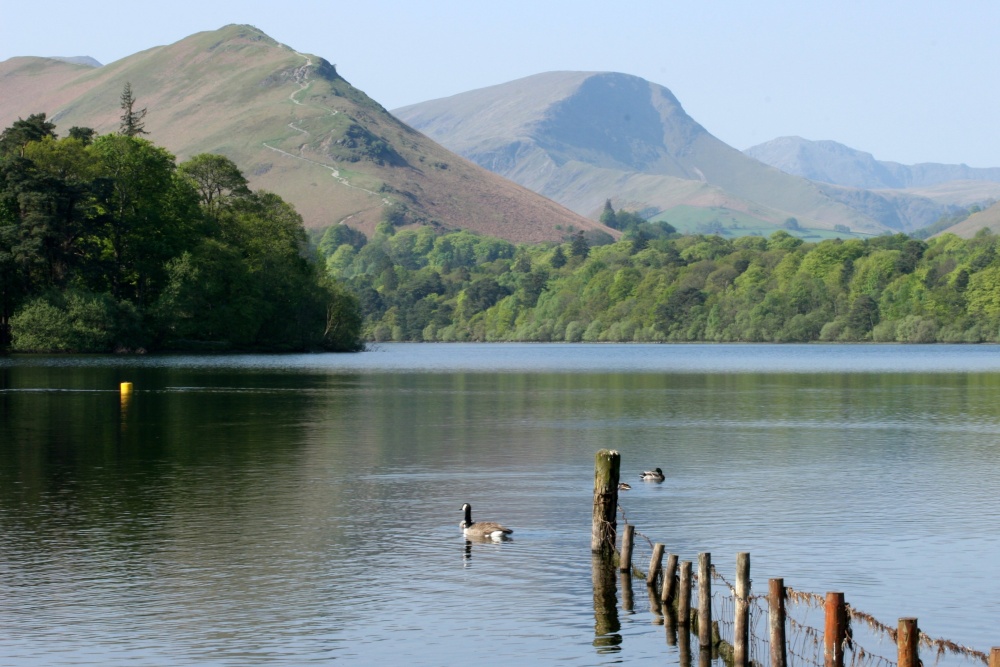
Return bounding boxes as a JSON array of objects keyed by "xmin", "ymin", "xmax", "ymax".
[{"xmin": 318, "ymin": 217, "xmax": 1000, "ymax": 343}]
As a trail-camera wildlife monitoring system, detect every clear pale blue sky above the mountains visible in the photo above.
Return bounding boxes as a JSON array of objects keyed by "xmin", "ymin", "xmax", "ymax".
[{"xmin": 0, "ymin": 0, "xmax": 1000, "ymax": 167}]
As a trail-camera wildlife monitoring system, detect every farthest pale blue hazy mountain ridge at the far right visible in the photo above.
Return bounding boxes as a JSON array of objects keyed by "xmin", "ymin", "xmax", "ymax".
[{"xmin": 744, "ymin": 137, "xmax": 1000, "ymax": 190}]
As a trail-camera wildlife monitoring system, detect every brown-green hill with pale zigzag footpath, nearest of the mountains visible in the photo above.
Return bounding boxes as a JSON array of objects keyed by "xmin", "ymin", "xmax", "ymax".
[{"xmin": 0, "ymin": 25, "xmax": 602, "ymax": 241}]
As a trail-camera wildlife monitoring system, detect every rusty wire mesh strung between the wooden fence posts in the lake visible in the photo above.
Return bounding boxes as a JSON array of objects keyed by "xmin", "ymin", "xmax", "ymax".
[{"xmin": 626, "ymin": 521, "xmax": 989, "ymax": 667}]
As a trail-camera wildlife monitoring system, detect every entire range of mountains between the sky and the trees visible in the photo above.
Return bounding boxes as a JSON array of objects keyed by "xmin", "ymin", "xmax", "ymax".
[{"xmin": 0, "ymin": 25, "xmax": 1000, "ymax": 242}]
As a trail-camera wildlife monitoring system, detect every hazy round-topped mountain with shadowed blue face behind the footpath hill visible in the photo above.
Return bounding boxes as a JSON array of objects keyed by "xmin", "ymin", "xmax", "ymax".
[{"xmin": 393, "ymin": 72, "xmax": 960, "ymax": 233}]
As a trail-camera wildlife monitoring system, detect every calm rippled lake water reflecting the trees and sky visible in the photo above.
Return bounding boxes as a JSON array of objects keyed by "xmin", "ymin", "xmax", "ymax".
[{"xmin": 0, "ymin": 344, "xmax": 1000, "ymax": 666}]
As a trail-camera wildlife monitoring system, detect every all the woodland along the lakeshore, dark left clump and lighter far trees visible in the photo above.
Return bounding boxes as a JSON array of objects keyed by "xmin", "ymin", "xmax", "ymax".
[{"xmin": 7, "ymin": 103, "xmax": 1000, "ymax": 352}]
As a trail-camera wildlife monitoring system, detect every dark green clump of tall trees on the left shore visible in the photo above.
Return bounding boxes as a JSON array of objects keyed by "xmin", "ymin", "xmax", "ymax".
[{"xmin": 0, "ymin": 111, "xmax": 361, "ymax": 352}]
